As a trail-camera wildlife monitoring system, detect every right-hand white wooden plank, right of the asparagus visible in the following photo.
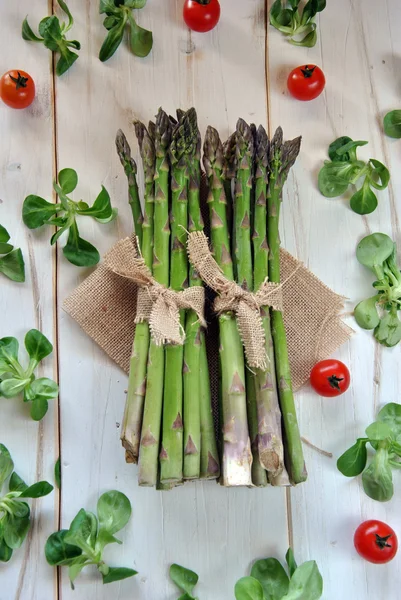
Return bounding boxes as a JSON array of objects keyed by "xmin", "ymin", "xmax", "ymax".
[{"xmin": 268, "ymin": 0, "xmax": 401, "ymax": 600}]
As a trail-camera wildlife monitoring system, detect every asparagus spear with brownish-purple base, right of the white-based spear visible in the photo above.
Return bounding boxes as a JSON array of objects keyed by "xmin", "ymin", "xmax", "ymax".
[{"xmin": 253, "ymin": 126, "xmax": 284, "ymax": 479}]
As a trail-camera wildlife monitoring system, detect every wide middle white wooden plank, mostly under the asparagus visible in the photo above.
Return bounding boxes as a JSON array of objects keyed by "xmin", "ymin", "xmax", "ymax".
[{"xmin": 57, "ymin": 0, "xmax": 288, "ymax": 600}]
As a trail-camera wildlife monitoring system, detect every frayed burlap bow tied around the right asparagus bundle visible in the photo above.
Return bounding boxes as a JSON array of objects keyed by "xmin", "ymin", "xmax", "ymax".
[{"xmin": 188, "ymin": 231, "xmax": 283, "ymax": 370}]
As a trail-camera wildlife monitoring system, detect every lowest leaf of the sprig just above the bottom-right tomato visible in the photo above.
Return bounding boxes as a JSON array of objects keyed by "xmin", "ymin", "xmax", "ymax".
[{"xmin": 362, "ymin": 448, "xmax": 394, "ymax": 502}]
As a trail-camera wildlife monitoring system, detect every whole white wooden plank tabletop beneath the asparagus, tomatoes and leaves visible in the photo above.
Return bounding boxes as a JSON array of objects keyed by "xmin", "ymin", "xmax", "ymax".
[{"xmin": 0, "ymin": 0, "xmax": 401, "ymax": 600}]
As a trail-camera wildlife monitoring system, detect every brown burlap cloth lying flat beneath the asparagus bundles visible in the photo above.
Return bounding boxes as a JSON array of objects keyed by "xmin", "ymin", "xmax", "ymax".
[{"xmin": 63, "ymin": 237, "xmax": 352, "ymax": 392}]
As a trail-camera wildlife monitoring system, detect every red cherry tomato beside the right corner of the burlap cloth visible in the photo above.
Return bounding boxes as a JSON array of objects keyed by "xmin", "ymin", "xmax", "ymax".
[{"xmin": 310, "ymin": 358, "xmax": 350, "ymax": 398}]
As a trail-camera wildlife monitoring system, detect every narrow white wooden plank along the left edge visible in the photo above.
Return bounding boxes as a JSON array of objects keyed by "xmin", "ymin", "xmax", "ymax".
[{"xmin": 0, "ymin": 0, "xmax": 58, "ymax": 600}]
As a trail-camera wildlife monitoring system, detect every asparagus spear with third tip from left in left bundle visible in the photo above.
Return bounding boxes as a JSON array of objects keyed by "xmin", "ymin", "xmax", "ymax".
[{"xmin": 138, "ymin": 109, "xmax": 171, "ymax": 486}]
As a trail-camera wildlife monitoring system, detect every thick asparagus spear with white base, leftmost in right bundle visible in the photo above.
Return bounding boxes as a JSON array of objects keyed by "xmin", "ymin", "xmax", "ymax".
[{"xmin": 203, "ymin": 126, "xmax": 252, "ymax": 486}]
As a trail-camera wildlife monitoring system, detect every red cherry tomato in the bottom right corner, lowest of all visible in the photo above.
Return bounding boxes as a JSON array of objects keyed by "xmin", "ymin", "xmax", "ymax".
[{"xmin": 354, "ymin": 519, "xmax": 398, "ymax": 564}]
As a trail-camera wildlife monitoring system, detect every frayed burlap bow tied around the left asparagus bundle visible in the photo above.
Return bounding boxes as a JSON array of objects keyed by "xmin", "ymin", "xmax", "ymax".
[{"xmin": 105, "ymin": 238, "xmax": 206, "ymax": 346}]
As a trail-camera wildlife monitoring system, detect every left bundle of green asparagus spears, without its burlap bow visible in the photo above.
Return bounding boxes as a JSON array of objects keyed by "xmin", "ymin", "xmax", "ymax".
[{"xmin": 116, "ymin": 109, "xmax": 220, "ymax": 489}]
